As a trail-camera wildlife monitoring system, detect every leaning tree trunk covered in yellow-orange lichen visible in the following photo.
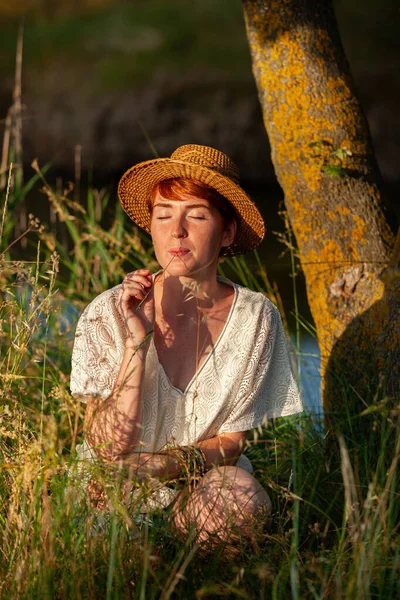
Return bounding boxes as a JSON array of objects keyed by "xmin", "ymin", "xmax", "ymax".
[{"xmin": 243, "ymin": 0, "xmax": 400, "ymax": 408}]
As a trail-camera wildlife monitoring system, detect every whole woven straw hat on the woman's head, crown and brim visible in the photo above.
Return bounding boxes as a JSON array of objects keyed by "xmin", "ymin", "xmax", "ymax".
[{"xmin": 118, "ymin": 144, "xmax": 265, "ymax": 256}]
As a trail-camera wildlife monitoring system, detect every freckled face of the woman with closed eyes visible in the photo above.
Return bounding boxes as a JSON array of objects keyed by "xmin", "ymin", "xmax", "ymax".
[{"xmin": 151, "ymin": 193, "xmax": 236, "ymax": 278}]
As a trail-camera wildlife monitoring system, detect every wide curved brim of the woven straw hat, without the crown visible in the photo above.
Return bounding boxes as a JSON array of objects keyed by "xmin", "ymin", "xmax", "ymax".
[{"xmin": 118, "ymin": 158, "xmax": 265, "ymax": 256}]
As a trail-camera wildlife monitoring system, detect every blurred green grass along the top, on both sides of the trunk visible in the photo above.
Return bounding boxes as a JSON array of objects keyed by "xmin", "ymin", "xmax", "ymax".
[{"xmin": 0, "ymin": 0, "xmax": 399, "ymax": 95}]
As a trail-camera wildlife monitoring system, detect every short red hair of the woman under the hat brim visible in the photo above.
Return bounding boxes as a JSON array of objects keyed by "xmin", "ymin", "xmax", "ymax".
[{"xmin": 147, "ymin": 177, "xmax": 237, "ymax": 226}]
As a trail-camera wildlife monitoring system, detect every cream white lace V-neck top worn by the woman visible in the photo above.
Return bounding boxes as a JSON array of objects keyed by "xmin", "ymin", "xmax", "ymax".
[{"xmin": 71, "ymin": 278, "xmax": 303, "ymax": 470}]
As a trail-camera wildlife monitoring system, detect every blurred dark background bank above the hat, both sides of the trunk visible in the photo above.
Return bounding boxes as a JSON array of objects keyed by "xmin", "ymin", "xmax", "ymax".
[{"xmin": 0, "ymin": 0, "xmax": 400, "ymax": 190}]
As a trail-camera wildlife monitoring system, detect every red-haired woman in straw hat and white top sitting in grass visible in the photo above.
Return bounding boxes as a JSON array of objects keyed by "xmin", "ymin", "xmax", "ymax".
[{"xmin": 71, "ymin": 145, "xmax": 302, "ymax": 542}]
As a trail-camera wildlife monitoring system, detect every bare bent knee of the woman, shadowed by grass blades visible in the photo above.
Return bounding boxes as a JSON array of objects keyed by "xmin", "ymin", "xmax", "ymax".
[{"xmin": 173, "ymin": 467, "xmax": 271, "ymax": 551}]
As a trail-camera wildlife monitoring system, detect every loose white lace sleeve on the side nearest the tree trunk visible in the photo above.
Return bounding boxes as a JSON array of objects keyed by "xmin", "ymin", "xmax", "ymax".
[{"xmin": 219, "ymin": 303, "xmax": 303, "ymax": 433}]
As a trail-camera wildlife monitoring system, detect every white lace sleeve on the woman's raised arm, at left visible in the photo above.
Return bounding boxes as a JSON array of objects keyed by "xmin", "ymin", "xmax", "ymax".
[{"xmin": 70, "ymin": 290, "xmax": 123, "ymax": 402}]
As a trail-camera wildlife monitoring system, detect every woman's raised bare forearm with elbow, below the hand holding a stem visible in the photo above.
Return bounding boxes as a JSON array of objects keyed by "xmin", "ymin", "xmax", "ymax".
[{"xmin": 85, "ymin": 341, "xmax": 147, "ymax": 460}]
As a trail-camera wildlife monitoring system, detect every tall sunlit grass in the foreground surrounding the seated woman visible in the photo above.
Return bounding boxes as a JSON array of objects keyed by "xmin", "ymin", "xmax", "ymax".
[{"xmin": 0, "ymin": 165, "xmax": 400, "ymax": 600}]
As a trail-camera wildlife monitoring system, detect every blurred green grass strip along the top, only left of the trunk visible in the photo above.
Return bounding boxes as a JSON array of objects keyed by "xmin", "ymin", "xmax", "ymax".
[{"xmin": 0, "ymin": 0, "xmax": 251, "ymax": 94}]
